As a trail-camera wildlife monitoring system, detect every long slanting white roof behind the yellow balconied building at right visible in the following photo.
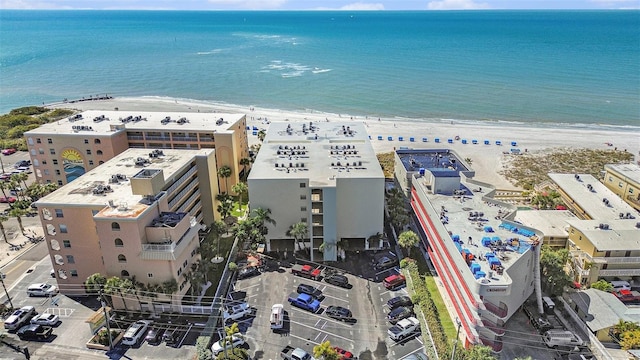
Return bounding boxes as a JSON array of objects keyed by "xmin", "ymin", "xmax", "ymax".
[{"xmin": 548, "ymin": 173, "xmax": 638, "ymax": 221}]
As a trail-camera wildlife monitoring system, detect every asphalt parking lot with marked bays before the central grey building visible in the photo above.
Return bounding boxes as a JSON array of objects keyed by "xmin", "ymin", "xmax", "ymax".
[{"xmin": 231, "ymin": 255, "xmax": 424, "ymax": 359}]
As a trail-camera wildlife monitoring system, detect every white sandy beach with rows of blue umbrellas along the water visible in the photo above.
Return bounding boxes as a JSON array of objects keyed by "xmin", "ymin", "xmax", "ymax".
[{"xmin": 48, "ymin": 97, "xmax": 640, "ymax": 189}]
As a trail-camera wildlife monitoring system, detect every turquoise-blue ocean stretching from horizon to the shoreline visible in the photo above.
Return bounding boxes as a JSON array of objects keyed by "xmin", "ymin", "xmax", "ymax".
[{"xmin": 0, "ymin": 10, "xmax": 640, "ymax": 130}]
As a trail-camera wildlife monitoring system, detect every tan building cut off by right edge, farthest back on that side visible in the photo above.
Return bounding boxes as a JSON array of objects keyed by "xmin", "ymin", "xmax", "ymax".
[{"xmin": 603, "ymin": 164, "xmax": 640, "ymax": 211}]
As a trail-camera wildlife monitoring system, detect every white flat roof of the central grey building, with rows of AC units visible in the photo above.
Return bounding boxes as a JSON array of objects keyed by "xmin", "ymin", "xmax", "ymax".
[{"xmin": 249, "ymin": 121, "xmax": 384, "ymax": 186}]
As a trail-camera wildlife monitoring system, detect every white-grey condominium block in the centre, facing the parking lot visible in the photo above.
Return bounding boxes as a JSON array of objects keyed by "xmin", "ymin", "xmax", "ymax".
[{"xmin": 248, "ymin": 122, "xmax": 385, "ymax": 261}]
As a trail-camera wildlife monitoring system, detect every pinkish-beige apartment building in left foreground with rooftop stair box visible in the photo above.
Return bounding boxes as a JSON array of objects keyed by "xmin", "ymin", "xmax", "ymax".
[{"xmin": 36, "ymin": 149, "xmax": 218, "ymax": 301}]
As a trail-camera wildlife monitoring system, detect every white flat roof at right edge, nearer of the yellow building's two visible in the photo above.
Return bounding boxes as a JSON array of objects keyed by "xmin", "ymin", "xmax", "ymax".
[{"xmin": 568, "ymin": 219, "xmax": 640, "ymax": 251}]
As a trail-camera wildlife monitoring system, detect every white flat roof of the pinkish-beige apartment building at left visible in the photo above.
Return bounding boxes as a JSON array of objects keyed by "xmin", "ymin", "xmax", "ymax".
[{"xmin": 36, "ymin": 148, "xmax": 214, "ymax": 212}]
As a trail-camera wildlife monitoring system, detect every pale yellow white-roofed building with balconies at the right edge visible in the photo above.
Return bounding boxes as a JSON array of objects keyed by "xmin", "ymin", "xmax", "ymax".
[{"xmin": 549, "ymin": 174, "xmax": 640, "ymax": 285}]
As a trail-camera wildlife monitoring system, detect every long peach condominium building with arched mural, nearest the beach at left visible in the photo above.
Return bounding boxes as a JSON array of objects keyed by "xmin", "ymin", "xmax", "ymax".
[{"xmin": 24, "ymin": 110, "xmax": 249, "ymax": 192}]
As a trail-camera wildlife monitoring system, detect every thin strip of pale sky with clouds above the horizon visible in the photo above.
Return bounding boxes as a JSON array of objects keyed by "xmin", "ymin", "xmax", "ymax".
[{"xmin": 0, "ymin": 0, "xmax": 640, "ymax": 11}]
